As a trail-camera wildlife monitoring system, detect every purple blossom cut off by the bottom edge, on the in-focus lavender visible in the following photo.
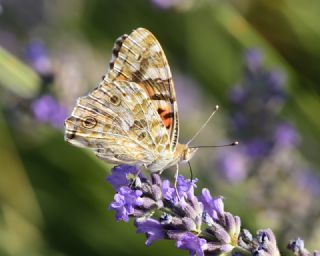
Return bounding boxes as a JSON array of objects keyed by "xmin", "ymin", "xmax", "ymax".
[{"xmin": 176, "ymin": 232, "xmax": 207, "ymax": 256}]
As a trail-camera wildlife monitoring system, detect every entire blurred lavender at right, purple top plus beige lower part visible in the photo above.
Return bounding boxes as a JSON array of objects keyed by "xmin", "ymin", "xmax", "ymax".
[{"xmin": 212, "ymin": 49, "xmax": 320, "ymax": 244}]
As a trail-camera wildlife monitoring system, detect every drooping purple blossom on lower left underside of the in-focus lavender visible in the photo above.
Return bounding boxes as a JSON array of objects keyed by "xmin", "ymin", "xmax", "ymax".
[{"xmin": 134, "ymin": 219, "xmax": 165, "ymax": 246}]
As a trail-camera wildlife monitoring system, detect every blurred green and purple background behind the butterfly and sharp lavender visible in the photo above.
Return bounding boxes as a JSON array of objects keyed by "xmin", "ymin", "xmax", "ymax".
[{"xmin": 0, "ymin": 0, "xmax": 320, "ymax": 256}]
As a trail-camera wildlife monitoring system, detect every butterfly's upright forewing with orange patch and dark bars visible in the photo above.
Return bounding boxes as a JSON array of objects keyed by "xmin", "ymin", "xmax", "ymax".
[{"xmin": 104, "ymin": 28, "xmax": 179, "ymax": 151}]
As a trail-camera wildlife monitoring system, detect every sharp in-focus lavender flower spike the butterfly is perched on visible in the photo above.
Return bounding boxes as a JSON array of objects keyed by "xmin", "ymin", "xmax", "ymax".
[{"xmin": 107, "ymin": 165, "xmax": 308, "ymax": 256}]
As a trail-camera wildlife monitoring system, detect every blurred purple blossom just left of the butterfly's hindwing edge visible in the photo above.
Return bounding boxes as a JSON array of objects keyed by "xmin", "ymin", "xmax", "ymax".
[{"xmin": 31, "ymin": 95, "xmax": 67, "ymax": 128}]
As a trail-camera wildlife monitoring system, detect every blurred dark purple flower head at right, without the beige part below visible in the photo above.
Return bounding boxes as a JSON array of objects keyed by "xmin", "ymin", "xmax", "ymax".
[{"xmin": 218, "ymin": 49, "xmax": 299, "ymax": 182}]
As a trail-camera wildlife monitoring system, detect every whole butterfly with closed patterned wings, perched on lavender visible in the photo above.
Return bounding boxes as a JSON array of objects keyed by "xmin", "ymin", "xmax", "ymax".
[{"xmin": 65, "ymin": 28, "xmax": 222, "ymax": 175}]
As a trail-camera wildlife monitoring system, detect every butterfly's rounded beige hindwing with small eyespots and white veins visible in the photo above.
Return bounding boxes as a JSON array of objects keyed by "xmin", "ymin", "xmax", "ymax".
[{"xmin": 65, "ymin": 81, "xmax": 170, "ymax": 165}]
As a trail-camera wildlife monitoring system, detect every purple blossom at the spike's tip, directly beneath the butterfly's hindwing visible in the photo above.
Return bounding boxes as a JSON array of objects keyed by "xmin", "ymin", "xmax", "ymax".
[{"xmin": 107, "ymin": 165, "xmax": 139, "ymax": 191}]
